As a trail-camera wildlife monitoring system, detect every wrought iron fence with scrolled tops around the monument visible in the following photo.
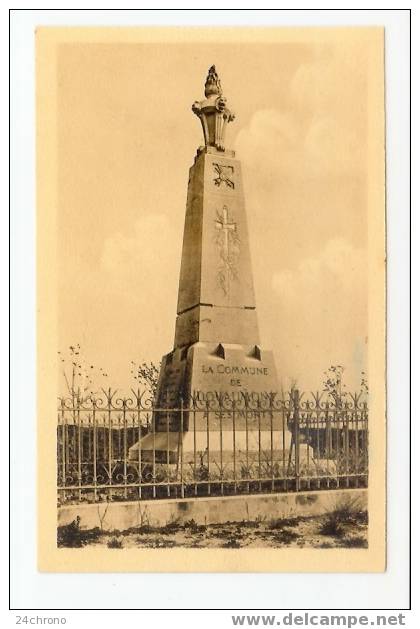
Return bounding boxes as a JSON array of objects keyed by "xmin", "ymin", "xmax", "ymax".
[{"xmin": 57, "ymin": 389, "xmax": 368, "ymax": 504}]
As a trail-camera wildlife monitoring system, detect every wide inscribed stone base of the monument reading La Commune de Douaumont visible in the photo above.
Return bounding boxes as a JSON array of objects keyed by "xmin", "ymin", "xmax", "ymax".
[{"xmin": 129, "ymin": 342, "xmax": 313, "ymax": 468}]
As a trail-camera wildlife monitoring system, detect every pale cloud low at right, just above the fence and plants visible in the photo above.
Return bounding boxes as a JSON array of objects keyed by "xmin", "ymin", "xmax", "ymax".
[{"xmin": 271, "ymin": 238, "xmax": 368, "ymax": 388}]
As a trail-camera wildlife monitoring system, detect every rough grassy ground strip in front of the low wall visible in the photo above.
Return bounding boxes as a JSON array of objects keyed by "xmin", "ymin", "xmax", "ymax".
[{"xmin": 58, "ymin": 509, "xmax": 368, "ymax": 549}]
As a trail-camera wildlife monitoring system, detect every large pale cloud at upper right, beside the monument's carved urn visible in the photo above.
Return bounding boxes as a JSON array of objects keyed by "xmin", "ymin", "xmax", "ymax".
[{"xmin": 236, "ymin": 41, "xmax": 368, "ymax": 179}]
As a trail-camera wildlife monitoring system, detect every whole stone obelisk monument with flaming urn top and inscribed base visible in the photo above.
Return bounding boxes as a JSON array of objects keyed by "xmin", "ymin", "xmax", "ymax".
[{"xmin": 130, "ymin": 66, "xmax": 291, "ymax": 468}]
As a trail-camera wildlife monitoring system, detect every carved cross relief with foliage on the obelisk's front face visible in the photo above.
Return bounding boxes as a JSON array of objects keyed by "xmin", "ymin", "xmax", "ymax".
[{"xmin": 215, "ymin": 205, "xmax": 240, "ymax": 295}]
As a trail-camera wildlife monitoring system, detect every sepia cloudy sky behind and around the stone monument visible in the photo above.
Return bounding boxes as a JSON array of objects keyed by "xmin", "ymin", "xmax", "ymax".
[{"xmin": 56, "ymin": 37, "xmax": 369, "ymax": 390}]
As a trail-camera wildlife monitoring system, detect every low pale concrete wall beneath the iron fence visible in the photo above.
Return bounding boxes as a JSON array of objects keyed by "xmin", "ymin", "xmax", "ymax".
[{"xmin": 58, "ymin": 489, "xmax": 367, "ymax": 531}]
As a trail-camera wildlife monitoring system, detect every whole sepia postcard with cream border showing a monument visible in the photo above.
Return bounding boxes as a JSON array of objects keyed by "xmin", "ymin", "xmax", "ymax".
[{"xmin": 36, "ymin": 27, "xmax": 386, "ymax": 572}]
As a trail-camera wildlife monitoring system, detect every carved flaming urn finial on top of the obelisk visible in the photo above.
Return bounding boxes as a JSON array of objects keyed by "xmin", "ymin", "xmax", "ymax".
[{"xmin": 192, "ymin": 65, "xmax": 235, "ymax": 151}]
